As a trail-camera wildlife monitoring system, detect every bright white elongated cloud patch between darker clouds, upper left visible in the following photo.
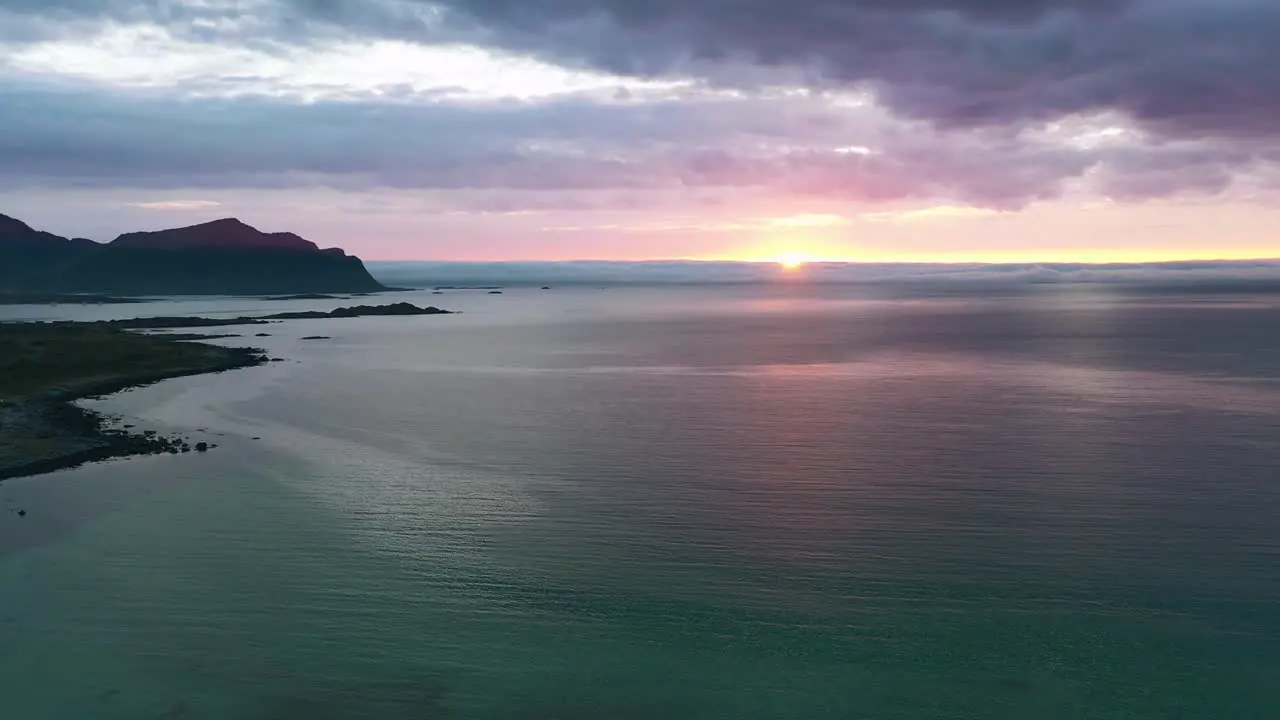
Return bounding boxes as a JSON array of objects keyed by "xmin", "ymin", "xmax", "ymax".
[{"xmin": 6, "ymin": 24, "xmax": 678, "ymax": 101}]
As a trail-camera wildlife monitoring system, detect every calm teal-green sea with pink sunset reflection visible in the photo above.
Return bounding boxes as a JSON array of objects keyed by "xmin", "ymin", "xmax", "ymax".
[{"xmin": 0, "ymin": 283, "xmax": 1280, "ymax": 720}]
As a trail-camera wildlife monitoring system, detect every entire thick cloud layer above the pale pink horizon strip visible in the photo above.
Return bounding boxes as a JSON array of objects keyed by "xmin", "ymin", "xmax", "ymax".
[{"xmin": 0, "ymin": 0, "xmax": 1280, "ymax": 215}]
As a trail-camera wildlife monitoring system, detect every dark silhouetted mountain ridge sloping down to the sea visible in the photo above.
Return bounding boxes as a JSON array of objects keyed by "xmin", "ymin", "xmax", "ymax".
[{"xmin": 0, "ymin": 215, "xmax": 387, "ymax": 296}]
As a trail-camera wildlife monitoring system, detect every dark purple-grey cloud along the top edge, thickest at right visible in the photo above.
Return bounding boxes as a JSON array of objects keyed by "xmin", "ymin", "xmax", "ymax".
[{"xmin": 0, "ymin": 0, "xmax": 1280, "ymax": 144}]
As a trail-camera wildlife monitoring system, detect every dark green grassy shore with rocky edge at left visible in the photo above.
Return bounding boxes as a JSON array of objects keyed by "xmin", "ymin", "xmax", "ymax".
[{"xmin": 0, "ymin": 323, "xmax": 266, "ymax": 479}]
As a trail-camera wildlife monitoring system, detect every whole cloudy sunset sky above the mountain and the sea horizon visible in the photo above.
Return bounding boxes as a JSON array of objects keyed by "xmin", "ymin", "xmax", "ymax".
[{"xmin": 0, "ymin": 0, "xmax": 1280, "ymax": 264}]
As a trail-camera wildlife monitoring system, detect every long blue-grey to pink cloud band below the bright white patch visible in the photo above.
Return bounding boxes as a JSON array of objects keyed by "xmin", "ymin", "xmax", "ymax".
[{"xmin": 0, "ymin": 79, "xmax": 1259, "ymax": 210}]
